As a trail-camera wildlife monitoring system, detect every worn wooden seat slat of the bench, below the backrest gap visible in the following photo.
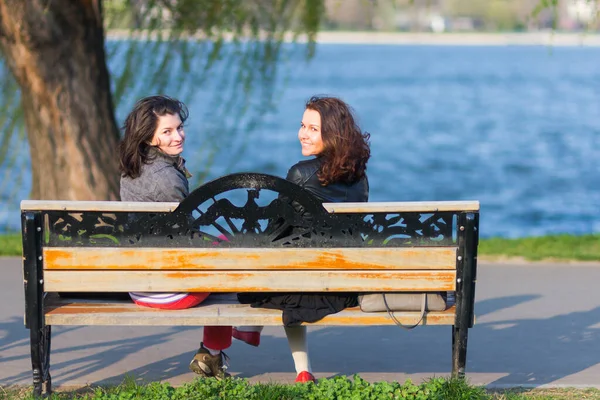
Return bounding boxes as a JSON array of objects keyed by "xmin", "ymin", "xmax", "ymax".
[{"xmin": 45, "ymin": 297, "xmax": 455, "ymax": 326}]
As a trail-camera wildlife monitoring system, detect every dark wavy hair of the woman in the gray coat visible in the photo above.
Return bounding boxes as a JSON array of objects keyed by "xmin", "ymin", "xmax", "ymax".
[{"xmin": 118, "ymin": 95, "xmax": 189, "ymax": 179}]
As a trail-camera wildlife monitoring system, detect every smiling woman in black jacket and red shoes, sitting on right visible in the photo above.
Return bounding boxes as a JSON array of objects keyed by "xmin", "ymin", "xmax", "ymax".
[{"xmin": 263, "ymin": 97, "xmax": 371, "ymax": 382}]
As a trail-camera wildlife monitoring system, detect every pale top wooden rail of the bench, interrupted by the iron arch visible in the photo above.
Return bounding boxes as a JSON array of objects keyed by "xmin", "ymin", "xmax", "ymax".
[{"xmin": 21, "ymin": 200, "xmax": 479, "ymax": 213}]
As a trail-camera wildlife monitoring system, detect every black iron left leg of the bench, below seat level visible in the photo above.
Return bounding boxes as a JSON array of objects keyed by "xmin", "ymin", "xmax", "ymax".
[{"xmin": 30, "ymin": 326, "xmax": 52, "ymax": 397}]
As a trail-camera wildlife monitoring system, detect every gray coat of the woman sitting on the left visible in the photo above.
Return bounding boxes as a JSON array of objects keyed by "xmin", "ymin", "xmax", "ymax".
[{"xmin": 121, "ymin": 150, "xmax": 190, "ymax": 202}]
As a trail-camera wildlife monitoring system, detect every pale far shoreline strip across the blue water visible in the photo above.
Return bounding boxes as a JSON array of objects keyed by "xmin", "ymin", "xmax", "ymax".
[{"xmin": 106, "ymin": 30, "xmax": 600, "ymax": 47}]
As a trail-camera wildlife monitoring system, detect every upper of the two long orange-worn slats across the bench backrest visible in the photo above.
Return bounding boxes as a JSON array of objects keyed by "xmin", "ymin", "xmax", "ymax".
[{"xmin": 43, "ymin": 247, "xmax": 456, "ymax": 270}]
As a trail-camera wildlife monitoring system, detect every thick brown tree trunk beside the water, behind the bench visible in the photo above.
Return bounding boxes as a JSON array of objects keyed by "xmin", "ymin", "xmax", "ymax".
[{"xmin": 0, "ymin": 0, "xmax": 119, "ymax": 200}]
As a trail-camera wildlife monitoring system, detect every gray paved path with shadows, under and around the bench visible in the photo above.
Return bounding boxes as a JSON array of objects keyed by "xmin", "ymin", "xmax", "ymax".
[{"xmin": 0, "ymin": 258, "xmax": 600, "ymax": 387}]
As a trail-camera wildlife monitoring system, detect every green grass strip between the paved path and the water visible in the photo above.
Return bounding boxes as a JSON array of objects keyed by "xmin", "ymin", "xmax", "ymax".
[{"xmin": 0, "ymin": 233, "xmax": 600, "ymax": 261}]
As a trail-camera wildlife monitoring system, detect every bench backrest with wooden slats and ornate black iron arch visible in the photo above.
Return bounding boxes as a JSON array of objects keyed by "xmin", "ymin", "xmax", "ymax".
[{"xmin": 21, "ymin": 175, "xmax": 479, "ymax": 310}]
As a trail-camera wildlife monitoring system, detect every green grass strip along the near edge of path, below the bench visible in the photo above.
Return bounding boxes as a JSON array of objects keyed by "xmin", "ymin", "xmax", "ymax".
[{"xmin": 0, "ymin": 375, "xmax": 600, "ymax": 400}]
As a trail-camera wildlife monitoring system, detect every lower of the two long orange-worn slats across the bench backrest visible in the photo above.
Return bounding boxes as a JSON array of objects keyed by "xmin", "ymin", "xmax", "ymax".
[{"xmin": 44, "ymin": 270, "xmax": 456, "ymax": 292}]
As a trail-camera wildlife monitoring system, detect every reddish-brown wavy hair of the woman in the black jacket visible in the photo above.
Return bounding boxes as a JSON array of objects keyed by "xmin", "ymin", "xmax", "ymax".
[{"xmin": 305, "ymin": 96, "xmax": 371, "ymax": 186}]
